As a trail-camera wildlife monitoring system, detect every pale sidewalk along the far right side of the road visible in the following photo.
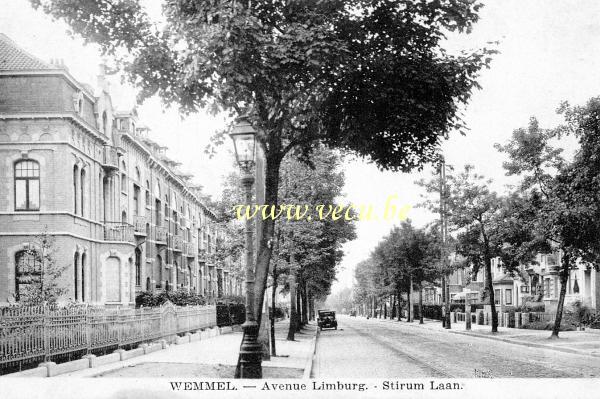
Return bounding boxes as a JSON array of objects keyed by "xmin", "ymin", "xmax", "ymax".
[{"xmin": 368, "ymin": 319, "xmax": 600, "ymax": 357}]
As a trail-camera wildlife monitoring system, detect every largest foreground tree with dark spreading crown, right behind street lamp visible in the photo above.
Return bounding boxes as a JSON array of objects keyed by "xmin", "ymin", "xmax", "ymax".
[{"xmin": 30, "ymin": 0, "xmax": 493, "ymax": 334}]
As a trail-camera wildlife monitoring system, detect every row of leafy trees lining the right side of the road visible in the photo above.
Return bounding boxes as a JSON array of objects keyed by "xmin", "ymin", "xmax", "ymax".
[{"xmin": 355, "ymin": 98, "xmax": 600, "ymax": 337}]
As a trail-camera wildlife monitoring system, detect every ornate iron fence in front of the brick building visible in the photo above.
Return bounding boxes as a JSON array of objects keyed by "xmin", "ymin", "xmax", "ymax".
[{"xmin": 0, "ymin": 302, "xmax": 217, "ymax": 374}]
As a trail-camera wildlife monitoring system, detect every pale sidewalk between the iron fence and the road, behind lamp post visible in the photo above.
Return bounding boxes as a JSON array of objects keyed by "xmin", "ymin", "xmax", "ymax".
[{"xmin": 60, "ymin": 321, "xmax": 317, "ymax": 378}]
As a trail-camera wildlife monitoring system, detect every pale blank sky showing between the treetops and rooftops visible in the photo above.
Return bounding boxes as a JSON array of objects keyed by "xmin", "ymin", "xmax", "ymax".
[{"xmin": 0, "ymin": 0, "xmax": 600, "ymax": 292}]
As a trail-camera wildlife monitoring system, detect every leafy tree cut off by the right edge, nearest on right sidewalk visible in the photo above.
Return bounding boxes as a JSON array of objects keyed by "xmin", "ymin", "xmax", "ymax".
[{"xmin": 497, "ymin": 108, "xmax": 600, "ymax": 338}]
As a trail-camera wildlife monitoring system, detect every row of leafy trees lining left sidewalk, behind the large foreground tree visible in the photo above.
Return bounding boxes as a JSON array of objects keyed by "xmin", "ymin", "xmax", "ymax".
[{"xmin": 214, "ymin": 147, "xmax": 356, "ymax": 354}]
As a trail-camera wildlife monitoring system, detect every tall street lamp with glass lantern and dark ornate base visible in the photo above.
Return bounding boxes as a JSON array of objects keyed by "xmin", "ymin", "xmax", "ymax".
[{"xmin": 229, "ymin": 118, "xmax": 262, "ymax": 378}]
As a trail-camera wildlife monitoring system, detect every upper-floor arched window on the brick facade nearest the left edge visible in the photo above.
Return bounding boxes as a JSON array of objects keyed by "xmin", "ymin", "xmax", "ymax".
[{"xmin": 15, "ymin": 160, "xmax": 40, "ymax": 211}]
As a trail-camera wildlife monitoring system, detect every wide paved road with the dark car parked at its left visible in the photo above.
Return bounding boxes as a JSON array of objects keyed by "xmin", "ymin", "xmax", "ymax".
[{"xmin": 313, "ymin": 316, "xmax": 600, "ymax": 378}]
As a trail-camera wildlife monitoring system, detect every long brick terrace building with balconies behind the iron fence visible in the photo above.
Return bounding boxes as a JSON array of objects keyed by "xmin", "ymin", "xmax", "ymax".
[{"xmin": 0, "ymin": 34, "xmax": 241, "ymax": 306}]
